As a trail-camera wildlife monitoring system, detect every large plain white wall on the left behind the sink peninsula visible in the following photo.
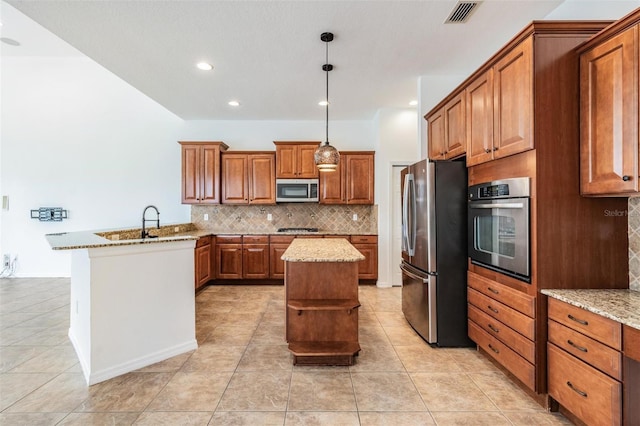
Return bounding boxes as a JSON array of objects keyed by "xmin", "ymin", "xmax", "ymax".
[{"xmin": 0, "ymin": 57, "xmax": 190, "ymax": 277}]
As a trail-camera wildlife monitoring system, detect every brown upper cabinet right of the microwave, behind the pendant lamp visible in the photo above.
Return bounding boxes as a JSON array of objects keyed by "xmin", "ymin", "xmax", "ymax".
[{"xmin": 320, "ymin": 151, "xmax": 375, "ymax": 204}]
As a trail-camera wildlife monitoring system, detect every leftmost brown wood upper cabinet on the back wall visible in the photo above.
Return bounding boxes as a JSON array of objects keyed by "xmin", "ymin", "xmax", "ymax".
[{"xmin": 179, "ymin": 141, "xmax": 228, "ymax": 204}]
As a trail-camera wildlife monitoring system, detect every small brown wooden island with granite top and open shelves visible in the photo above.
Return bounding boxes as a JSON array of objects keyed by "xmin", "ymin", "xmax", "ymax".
[{"xmin": 282, "ymin": 238, "xmax": 364, "ymax": 365}]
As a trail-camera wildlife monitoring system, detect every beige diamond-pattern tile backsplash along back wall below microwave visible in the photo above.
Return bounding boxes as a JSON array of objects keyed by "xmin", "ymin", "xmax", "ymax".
[{"xmin": 191, "ymin": 203, "xmax": 378, "ymax": 234}]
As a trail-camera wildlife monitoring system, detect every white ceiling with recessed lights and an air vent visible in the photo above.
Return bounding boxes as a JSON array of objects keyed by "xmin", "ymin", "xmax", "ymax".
[{"xmin": 0, "ymin": 0, "xmax": 632, "ymax": 120}]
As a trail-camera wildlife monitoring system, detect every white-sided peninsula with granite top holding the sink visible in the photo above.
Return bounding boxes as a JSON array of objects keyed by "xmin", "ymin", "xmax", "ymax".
[{"xmin": 46, "ymin": 226, "xmax": 198, "ymax": 385}]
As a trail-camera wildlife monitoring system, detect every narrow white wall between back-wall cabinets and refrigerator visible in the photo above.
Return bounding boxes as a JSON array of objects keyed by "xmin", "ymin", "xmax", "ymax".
[{"xmin": 375, "ymin": 108, "xmax": 421, "ymax": 286}]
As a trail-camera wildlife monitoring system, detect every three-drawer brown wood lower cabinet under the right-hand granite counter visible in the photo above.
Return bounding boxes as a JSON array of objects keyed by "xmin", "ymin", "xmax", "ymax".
[{"xmin": 547, "ymin": 298, "xmax": 624, "ymax": 425}]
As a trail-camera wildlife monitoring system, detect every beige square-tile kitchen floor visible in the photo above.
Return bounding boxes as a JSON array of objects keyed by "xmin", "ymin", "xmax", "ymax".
[{"xmin": 0, "ymin": 279, "xmax": 570, "ymax": 426}]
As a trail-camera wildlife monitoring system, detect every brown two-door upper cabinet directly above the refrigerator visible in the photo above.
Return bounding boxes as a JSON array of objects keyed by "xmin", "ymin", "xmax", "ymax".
[{"xmin": 425, "ymin": 92, "xmax": 467, "ymax": 160}]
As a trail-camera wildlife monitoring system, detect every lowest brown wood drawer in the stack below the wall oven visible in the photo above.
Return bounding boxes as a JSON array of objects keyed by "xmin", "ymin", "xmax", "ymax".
[{"xmin": 469, "ymin": 321, "xmax": 536, "ymax": 389}]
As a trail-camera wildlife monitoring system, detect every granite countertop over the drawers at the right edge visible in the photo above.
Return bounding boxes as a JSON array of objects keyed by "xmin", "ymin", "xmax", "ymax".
[{"xmin": 541, "ymin": 289, "xmax": 640, "ymax": 330}]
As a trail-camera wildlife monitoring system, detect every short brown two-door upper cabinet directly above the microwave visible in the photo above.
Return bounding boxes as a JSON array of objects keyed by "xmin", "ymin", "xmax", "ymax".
[{"xmin": 273, "ymin": 141, "xmax": 320, "ymax": 179}]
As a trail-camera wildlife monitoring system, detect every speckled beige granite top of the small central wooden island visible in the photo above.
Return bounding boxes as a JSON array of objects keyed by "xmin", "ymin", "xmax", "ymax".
[{"xmin": 281, "ymin": 238, "xmax": 365, "ymax": 262}]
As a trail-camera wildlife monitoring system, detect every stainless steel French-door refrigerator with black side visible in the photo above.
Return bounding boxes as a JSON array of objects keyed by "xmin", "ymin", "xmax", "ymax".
[{"xmin": 400, "ymin": 160, "xmax": 473, "ymax": 347}]
